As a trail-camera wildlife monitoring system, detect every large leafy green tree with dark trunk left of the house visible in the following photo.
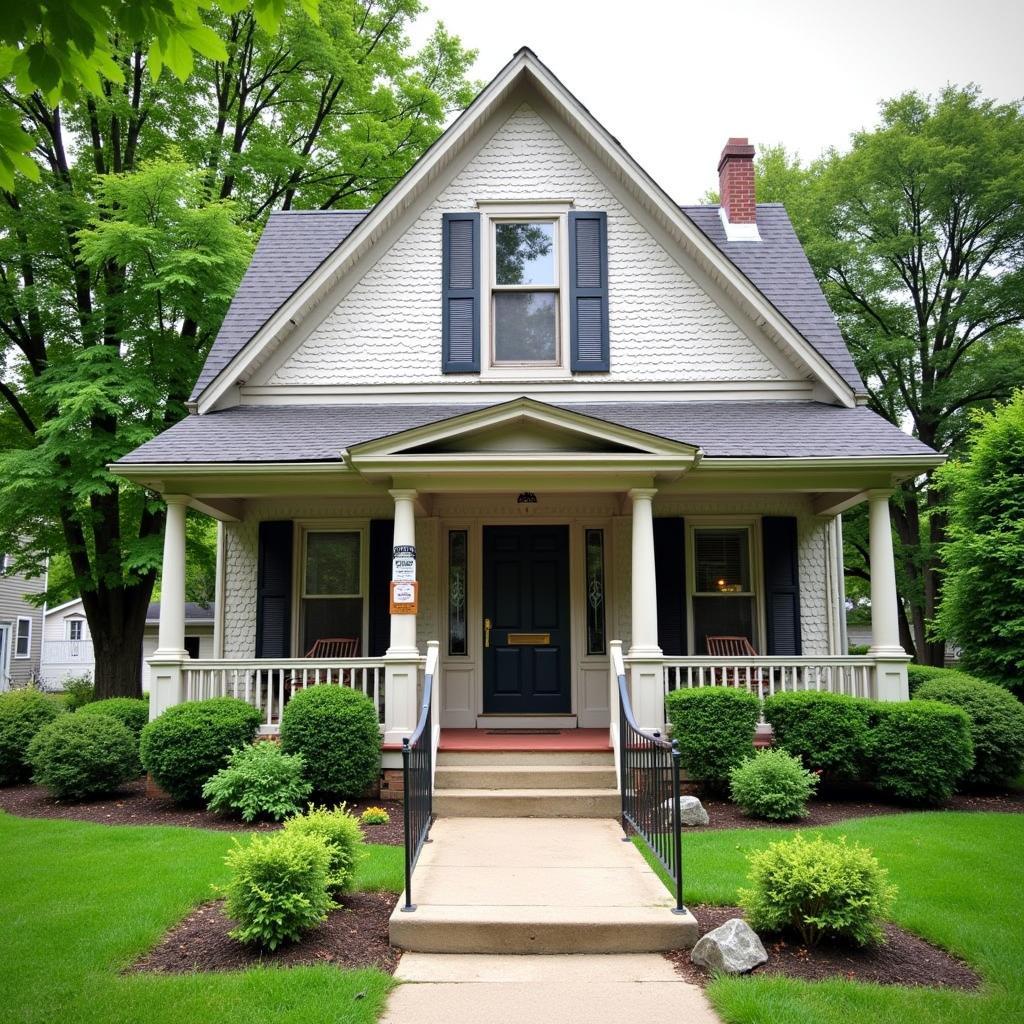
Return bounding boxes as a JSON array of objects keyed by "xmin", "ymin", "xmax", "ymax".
[{"xmin": 0, "ymin": 0, "xmax": 473, "ymax": 697}]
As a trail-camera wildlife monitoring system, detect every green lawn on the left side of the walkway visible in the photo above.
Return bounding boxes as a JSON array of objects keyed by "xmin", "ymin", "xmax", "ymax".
[{"xmin": 0, "ymin": 813, "xmax": 402, "ymax": 1024}]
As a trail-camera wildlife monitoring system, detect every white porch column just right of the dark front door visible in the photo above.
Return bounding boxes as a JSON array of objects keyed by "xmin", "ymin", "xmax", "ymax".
[{"xmin": 629, "ymin": 487, "xmax": 665, "ymax": 730}]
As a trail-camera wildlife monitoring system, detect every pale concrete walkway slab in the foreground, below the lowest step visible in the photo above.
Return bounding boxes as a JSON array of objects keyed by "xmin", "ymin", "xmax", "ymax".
[{"xmin": 382, "ymin": 953, "xmax": 718, "ymax": 1024}]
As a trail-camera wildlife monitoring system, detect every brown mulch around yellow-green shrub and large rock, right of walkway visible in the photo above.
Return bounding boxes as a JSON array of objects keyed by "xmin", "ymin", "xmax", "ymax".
[{"xmin": 665, "ymin": 904, "xmax": 981, "ymax": 991}]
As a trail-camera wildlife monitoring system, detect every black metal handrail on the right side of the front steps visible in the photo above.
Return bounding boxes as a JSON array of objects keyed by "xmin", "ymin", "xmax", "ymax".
[{"xmin": 618, "ymin": 673, "xmax": 686, "ymax": 913}]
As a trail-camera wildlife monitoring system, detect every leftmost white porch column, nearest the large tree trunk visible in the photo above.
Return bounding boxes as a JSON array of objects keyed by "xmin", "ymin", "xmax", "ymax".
[{"xmin": 150, "ymin": 495, "xmax": 188, "ymax": 719}]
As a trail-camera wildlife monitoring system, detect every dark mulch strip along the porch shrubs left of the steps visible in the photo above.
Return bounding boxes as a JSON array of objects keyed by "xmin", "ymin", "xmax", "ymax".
[{"xmin": 0, "ymin": 778, "xmax": 403, "ymax": 846}]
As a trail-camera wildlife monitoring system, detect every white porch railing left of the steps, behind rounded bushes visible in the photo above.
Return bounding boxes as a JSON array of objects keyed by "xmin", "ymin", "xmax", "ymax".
[{"xmin": 181, "ymin": 657, "xmax": 385, "ymax": 731}]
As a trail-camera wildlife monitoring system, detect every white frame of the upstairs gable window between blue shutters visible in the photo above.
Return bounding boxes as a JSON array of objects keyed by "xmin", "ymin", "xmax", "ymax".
[{"xmin": 476, "ymin": 199, "xmax": 573, "ymax": 380}]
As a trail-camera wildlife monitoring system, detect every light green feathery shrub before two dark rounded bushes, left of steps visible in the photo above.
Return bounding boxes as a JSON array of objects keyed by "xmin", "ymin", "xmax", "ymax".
[{"xmin": 203, "ymin": 742, "xmax": 312, "ymax": 821}]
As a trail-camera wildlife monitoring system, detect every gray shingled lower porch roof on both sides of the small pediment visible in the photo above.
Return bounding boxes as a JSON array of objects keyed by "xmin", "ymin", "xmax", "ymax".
[{"xmin": 120, "ymin": 401, "xmax": 934, "ymax": 466}]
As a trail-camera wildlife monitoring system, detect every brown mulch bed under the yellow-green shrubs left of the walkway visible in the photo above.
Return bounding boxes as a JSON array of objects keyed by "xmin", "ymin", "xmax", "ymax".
[{"xmin": 128, "ymin": 893, "xmax": 401, "ymax": 974}]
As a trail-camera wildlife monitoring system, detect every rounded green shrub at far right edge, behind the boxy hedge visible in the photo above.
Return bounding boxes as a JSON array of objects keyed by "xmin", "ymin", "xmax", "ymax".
[{"xmin": 914, "ymin": 675, "xmax": 1024, "ymax": 785}]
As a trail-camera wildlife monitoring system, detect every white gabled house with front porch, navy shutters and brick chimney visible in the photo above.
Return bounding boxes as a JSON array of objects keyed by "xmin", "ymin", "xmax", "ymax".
[{"xmin": 113, "ymin": 49, "xmax": 941, "ymax": 778}]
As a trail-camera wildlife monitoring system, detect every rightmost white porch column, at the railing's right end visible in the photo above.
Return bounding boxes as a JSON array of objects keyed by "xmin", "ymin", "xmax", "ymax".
[{"xmin": 867, "ymin": 490, "xmax": 910, "ymax": 700}]
